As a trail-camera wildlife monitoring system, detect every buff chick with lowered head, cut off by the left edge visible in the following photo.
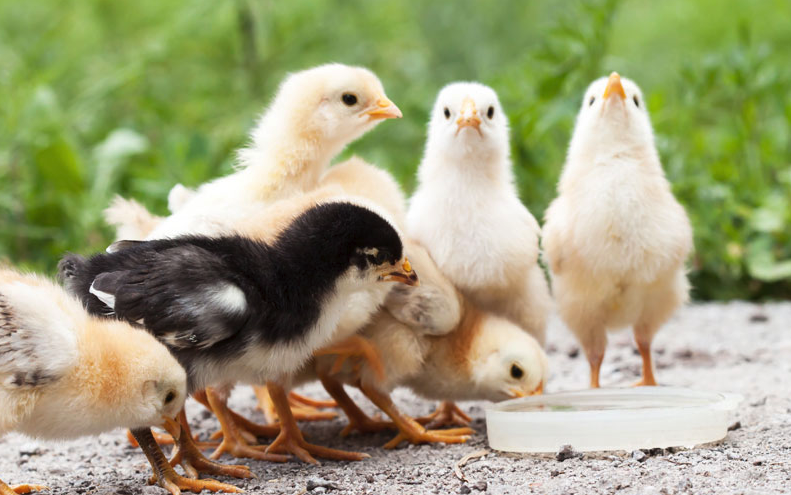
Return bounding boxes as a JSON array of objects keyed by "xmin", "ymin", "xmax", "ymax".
[{"xmin": 0, "ymin": 267, "xmax": 189, "ymax": 495}]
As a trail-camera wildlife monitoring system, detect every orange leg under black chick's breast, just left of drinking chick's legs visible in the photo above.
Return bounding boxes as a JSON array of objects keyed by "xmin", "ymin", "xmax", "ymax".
[{"xmin": 267, "ymin": 382, "xmax": 370, "ymax": 464}]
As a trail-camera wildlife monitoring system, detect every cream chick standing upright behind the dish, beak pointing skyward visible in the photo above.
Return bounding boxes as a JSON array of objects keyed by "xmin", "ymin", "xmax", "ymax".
[{"xmin": 544, "ymin": 72, "xmax": 692, "ymax": 387}]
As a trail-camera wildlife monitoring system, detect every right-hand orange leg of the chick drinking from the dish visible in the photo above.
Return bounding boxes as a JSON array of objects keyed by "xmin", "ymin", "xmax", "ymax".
[{"xmin": 360, "ymin": 383, "xmax": 475, "ymax": 449}]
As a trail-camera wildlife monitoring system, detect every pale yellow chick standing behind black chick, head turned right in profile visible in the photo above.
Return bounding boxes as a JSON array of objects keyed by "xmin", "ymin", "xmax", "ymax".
[{"xmin": 148, "ymin": 64, "xmax": 401, "ymax": 239}]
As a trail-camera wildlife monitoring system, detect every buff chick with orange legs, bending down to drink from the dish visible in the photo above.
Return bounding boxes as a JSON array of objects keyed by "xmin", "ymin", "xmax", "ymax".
[{"xmin": 315, "ymin": 244, "xmax": 547, "ymax": 448}]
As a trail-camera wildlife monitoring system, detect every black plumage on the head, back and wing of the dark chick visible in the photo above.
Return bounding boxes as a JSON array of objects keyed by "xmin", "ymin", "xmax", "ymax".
[{"xmin": 59, "ymin": 203, "xmax": 403, "ymax": 392}]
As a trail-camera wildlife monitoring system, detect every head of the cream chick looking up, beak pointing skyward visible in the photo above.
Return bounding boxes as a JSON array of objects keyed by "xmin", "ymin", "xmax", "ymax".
[{"xmin": 569, "ymin": 72, "xmax": 654, "ymax": 158}]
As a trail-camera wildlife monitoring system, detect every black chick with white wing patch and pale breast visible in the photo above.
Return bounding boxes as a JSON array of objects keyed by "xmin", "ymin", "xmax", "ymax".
[{"xmin": 60, "ymin": 202, "xmax": 417, "ymax": 488}]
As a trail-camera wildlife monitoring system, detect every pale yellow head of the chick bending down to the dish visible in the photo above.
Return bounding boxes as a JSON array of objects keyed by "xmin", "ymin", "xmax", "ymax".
[{"xmin": 470, "ymin": 315, "xmax": 548, "ymax": 401}]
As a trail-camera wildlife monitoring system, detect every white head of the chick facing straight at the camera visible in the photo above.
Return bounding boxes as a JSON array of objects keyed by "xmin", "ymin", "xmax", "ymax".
[{"xmin": 426, "ymin": 82, "xmax": 508, "ymax": 161}]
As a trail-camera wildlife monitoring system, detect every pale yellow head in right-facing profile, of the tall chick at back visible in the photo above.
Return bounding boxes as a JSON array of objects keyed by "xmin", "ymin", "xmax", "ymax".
[{"xmin": 278, "ymin": 64, "xmax": 401, "ymax": 146}]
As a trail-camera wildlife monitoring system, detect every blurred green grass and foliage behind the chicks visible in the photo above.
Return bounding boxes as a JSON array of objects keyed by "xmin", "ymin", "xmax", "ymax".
[{"xmin": 0, "ymin": 0, "xmax": 791, "ymax": 300}]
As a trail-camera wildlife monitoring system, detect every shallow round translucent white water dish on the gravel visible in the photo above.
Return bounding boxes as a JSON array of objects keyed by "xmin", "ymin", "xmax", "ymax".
[{"xmin": 486, "ymin": 387, "xmax": 742, "ymax": 452}]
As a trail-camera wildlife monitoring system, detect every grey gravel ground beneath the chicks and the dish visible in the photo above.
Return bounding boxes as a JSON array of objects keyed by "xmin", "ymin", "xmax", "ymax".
[{"xmin": 0, "ymin": 303, "xmax": 791, "ymax": 495}]
